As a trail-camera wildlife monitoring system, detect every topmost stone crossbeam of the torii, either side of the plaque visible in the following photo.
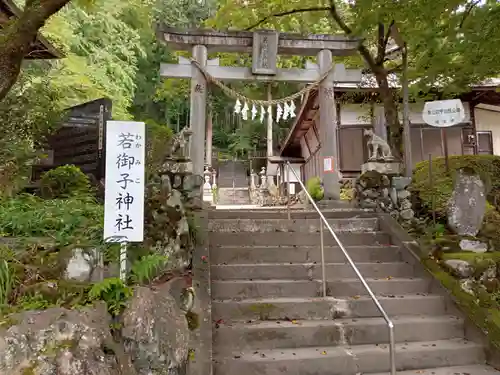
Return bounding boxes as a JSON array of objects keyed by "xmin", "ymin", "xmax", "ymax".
[{"xmin": 157, "ymin": 25, "xmax": 361, "ymax": 56}]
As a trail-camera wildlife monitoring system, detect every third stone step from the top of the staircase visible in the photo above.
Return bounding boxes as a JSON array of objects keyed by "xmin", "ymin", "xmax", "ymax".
[{"xmin": 209, "ymin": 232, "xmax": 391, "ymax": 247}]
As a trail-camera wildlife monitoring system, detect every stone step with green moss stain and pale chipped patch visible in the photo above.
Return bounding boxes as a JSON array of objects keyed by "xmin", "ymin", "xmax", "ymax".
[{"xmin": 212, "ymin": 294, "xmax": 446, "ymax": 322}]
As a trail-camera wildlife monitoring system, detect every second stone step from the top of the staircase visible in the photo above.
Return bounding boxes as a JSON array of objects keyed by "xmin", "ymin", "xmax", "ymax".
[{"xmin": 208, "ymin": 218, "xmax": 379, "ymax": 236}]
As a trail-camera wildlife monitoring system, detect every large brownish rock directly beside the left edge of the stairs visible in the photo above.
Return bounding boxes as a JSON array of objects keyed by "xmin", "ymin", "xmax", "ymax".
[{"xmin": 122, "ymin": 281, "xmax": 190, "ymax": 375}]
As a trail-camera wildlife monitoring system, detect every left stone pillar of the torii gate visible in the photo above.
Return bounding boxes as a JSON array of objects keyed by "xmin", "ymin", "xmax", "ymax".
[{"xmin": 189, "ymin": 45, "xmax": 207, "ymax": 176}]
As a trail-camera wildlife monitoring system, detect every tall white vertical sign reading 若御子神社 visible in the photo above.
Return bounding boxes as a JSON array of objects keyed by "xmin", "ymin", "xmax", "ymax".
[{"xmin": 104, "ymin": 121, "xmax": 146, "ymax": 242}]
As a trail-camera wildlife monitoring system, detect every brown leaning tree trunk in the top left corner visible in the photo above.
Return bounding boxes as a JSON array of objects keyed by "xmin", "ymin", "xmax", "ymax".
[{"xmin": 0, "ymin": 0, "xmax": 71, "ymax": 101}]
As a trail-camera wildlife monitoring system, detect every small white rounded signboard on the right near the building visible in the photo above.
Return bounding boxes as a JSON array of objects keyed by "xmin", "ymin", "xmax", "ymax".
[{"xmin": 422, "ymin": 99, "xmax": 465, "ymax": 128}]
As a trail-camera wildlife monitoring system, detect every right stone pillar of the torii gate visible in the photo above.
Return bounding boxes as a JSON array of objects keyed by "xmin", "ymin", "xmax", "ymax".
[{"xmin": 317, "ymin": 50, "xmax": 340, "ymax": 200}]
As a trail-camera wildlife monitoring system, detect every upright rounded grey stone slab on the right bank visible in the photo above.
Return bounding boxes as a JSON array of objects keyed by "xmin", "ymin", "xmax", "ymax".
[{"xmin": 447, "ymin": 170, "xmax": 486, "ymax": 236}]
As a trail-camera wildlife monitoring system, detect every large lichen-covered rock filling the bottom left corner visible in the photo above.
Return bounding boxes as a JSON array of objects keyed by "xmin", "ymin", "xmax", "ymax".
[{"xmin": 0, "ymin": 303, "xmax": 120, "ymax": 375}]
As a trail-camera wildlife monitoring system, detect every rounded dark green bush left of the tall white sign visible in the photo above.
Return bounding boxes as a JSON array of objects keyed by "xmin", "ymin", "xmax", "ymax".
[{"xmin": 40, "ymin": 165, "xmax": 91, "ymax": 199}]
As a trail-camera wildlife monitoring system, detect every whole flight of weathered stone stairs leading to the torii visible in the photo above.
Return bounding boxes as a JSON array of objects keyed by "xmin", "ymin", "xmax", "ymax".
[{"xmin": 209, "ymin": 209, "xmax": 500, "ymax": 375}]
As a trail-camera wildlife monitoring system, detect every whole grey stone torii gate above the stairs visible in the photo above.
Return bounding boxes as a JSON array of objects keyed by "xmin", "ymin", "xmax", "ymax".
[{"xmin": 157, "ymin": 27, "xmax": 361, "ymax": 200}]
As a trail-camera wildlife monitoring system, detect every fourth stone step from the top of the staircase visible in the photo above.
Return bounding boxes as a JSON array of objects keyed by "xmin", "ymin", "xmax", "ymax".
[{"xmin": 210, "ymin": 246, "xmax": 401, "ymax": 264}]
